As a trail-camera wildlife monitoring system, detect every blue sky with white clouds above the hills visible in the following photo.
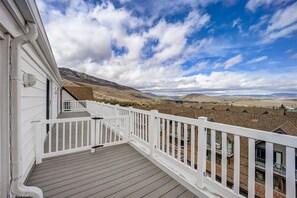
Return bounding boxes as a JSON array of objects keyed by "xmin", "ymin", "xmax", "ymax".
[{"xmin": 36, "ymin": 0, "xmax": 297, "ymax": 95}]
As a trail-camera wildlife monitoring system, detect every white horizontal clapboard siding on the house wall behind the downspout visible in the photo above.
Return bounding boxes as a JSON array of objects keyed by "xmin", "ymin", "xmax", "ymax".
[{"xmin": 20, "ymin": 45, "xmax": 58, "ymax": 178}]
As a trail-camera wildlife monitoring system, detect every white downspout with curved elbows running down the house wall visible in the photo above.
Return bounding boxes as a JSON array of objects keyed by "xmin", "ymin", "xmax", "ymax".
[{"xmin": 10, "ymin": 22, "xmax": 43, "ymax": 197}]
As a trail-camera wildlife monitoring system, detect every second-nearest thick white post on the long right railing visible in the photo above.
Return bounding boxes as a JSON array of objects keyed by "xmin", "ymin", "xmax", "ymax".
[{"xmin": 149, "ymin": 110, "xmax": 158, "ymax": 158}]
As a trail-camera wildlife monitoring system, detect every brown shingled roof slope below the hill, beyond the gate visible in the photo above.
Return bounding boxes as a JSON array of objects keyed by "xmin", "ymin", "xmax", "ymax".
[{"xmin": 64, "ymin": 86, "xmax": 94, "ymax": 100}]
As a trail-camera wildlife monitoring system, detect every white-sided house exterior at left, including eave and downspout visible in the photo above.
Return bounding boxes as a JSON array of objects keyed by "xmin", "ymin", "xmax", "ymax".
[{"xmin": 0, "ymin": 0, "xmax": 62, "ymax": 197}]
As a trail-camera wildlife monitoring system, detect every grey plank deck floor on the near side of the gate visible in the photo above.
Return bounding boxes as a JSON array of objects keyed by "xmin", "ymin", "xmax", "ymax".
[{"xmin": 26, "ymin": 144, "xmax": 195, "ymax": 198}]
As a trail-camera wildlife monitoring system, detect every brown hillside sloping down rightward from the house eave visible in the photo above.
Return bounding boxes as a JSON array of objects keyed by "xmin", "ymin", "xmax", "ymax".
[{"xmin": 59, "ymin": 68, "xmax": 153, "ymax": 101}]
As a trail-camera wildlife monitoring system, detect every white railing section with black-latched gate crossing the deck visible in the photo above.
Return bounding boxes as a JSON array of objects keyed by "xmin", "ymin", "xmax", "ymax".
[{"xmin": 35, "ymin": 116, "xmax": 129, "ymax": 164}]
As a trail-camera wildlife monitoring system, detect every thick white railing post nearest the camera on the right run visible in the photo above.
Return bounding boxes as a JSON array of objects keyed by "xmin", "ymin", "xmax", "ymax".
[{"xmin": 197, "ymin": 117, "xmax": 207, "ymax": 188}]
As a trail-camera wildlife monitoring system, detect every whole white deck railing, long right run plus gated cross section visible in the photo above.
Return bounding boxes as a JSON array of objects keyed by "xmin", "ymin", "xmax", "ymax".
[{"xmin": 37, "ymin": 101, "xmax": 297, "ymax": 197}]
